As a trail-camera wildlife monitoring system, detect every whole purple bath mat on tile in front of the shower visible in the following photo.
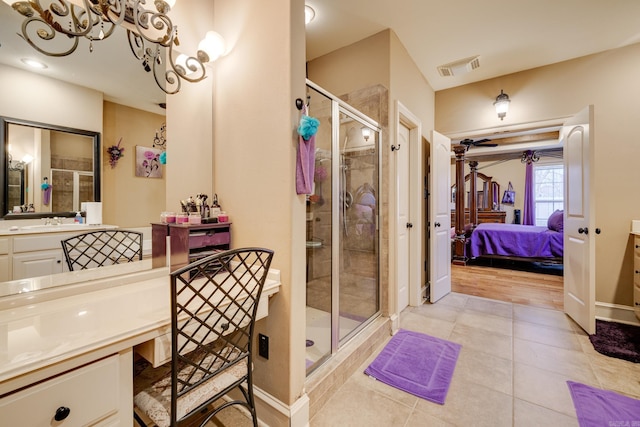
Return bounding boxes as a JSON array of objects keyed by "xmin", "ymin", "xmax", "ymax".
[{"xmin": 364, "ymin": 329, "xmax": 461, "ymax": 405}]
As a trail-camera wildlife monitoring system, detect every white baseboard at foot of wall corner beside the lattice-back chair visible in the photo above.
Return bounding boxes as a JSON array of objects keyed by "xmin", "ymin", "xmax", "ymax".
[{"xmin": 253, "ymin": 385, "xmax": 309, "ymax": 427}]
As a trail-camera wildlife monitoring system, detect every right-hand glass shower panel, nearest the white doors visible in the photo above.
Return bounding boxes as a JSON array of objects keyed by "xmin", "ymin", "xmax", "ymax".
[{"xmin": 335, "ymin": 111, "xmax": 379, "ymax": 341}]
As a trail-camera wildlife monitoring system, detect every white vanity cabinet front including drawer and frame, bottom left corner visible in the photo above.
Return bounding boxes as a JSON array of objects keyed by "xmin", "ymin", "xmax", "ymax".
[{"xmin": 0, "ymin": 351, "xmax": 133, "ymax": 427}]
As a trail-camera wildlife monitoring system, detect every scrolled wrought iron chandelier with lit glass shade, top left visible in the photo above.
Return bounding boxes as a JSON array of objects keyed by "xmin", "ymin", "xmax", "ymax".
[{"xmin": 3, "ymin": 0, "xmax": 225, "ymax": 94}]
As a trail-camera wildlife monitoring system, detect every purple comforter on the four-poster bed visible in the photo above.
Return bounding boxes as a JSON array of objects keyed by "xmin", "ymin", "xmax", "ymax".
[{"xmin": 470, "ymin": 223, "xmax": 563, "ymax": 258}]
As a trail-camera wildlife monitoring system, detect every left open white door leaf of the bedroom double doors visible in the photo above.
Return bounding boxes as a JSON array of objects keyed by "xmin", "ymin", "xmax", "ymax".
[{"xmin": 429, "ymin": 131, "xmax": 451, "ymax": 303}]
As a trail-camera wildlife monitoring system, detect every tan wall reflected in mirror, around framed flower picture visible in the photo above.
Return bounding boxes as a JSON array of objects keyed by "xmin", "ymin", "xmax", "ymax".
[{"xmin": 101, "ymin": 102, "xmax": 166, "ymax": 228}]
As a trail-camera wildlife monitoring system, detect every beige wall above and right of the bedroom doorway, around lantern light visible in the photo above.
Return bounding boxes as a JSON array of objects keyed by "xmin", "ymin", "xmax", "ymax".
[{"xmin": 435, "ymin": 44, "xmax": 640, "ymax": 306}]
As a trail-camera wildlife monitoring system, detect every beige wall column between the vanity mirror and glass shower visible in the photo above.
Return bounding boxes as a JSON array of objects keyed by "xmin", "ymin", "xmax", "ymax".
[{"xmin": 213, "ymin": 0, "xmax": 306, "ymax": 410}]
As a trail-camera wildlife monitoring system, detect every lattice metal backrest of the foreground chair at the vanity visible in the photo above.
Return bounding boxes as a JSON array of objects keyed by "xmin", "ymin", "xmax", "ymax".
[{"xmin": 171, "ymin": 248, "xmax": 273, "ymax": 425}]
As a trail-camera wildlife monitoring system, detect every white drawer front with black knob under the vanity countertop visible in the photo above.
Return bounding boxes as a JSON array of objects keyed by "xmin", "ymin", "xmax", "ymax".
[{"xmin": 0, "ymin": 356, "xmax": 120, "ymax": 427}]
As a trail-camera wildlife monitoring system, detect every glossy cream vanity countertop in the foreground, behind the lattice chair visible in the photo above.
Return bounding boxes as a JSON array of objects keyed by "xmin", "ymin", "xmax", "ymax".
[{"xmin": 0, "ymin": 268, "xmax": 280, "ymax": 395}]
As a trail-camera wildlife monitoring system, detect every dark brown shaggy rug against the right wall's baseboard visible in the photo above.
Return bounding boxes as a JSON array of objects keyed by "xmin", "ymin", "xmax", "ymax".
[{"xmin": 589, "ymin": 319, "xmax": 640, "ymax": 363}]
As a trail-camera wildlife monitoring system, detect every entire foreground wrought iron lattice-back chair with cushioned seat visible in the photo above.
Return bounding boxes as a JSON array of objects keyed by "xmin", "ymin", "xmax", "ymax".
[{"xmin": 134, "ymin": 248, "xmax": 273, "ymax": 427}]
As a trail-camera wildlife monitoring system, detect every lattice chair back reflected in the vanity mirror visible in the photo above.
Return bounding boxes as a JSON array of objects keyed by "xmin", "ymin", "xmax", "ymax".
[{"xmin": 61, "ymin": 230, "xmax": 142, "ymax": 271}]
